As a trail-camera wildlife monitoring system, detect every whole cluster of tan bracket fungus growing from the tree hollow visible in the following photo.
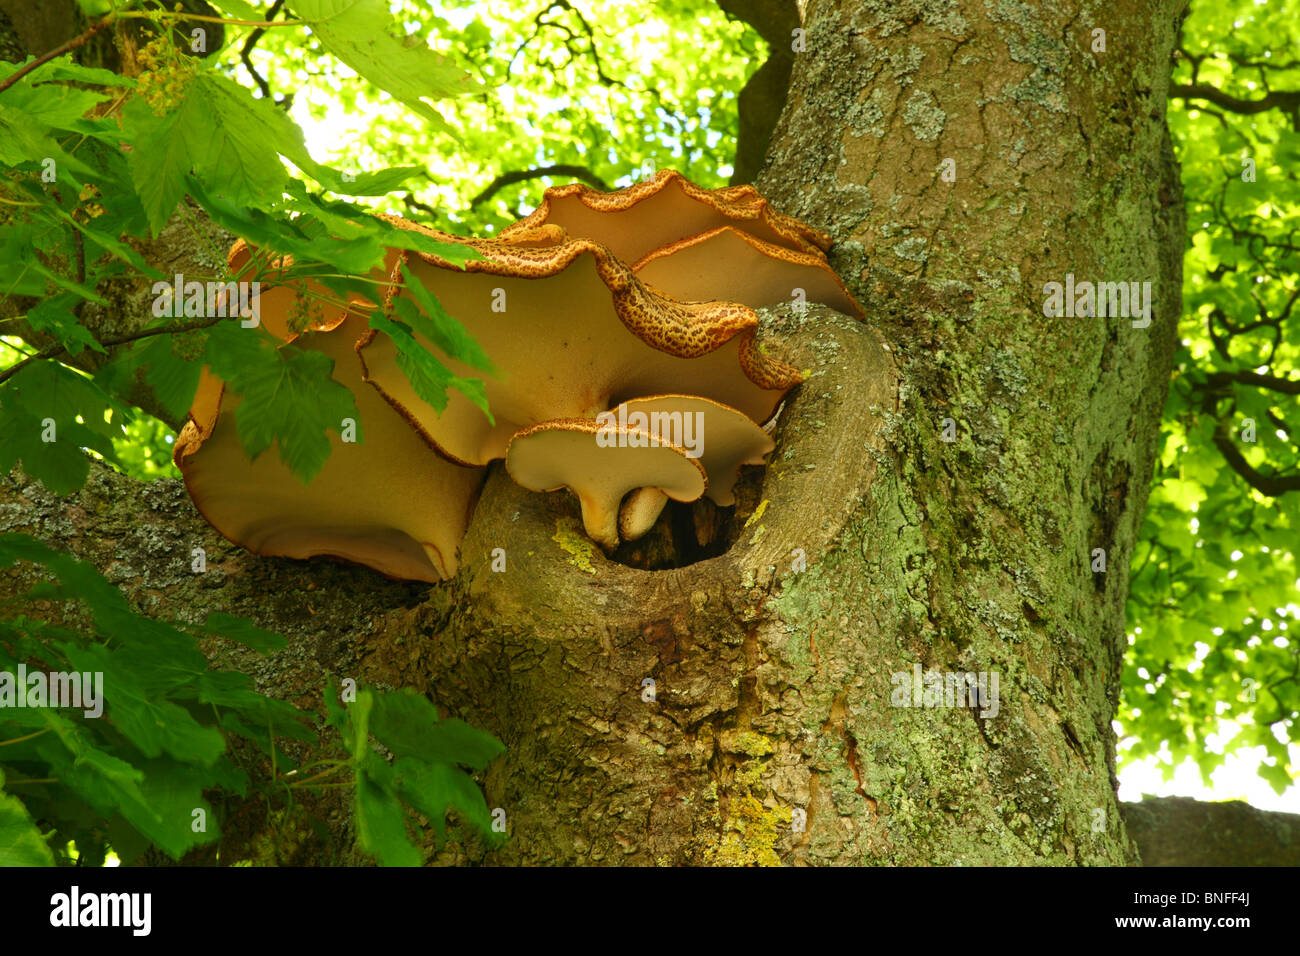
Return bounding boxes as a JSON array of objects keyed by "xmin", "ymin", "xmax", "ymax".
[{"xmin": 174, "ymin": 172, "xmax": 862, "ymax": 581}]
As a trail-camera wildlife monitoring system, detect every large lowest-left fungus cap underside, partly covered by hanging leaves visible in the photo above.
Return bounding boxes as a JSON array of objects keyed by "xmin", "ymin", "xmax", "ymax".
[{"xmin": 176, "ymin": 312, "xmax": 485, "ymax": 581}]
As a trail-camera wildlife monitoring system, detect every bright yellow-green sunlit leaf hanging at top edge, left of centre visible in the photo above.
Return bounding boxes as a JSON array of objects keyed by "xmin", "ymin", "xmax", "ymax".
[{"xmin": 289, "ymin": 0, "xmax": 478, "ymax": 129}]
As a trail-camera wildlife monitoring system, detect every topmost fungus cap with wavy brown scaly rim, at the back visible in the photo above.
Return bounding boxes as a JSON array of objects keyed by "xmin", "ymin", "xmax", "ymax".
[{"xmin": 501, "ymin": 169, "xmax": 831, "ymax": 265}]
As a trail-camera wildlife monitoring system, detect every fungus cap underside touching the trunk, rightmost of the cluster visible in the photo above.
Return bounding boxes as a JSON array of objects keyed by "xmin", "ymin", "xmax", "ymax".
[{"xmin": 632, "ymin": 226, "xmax": 865, "ymax": 319}]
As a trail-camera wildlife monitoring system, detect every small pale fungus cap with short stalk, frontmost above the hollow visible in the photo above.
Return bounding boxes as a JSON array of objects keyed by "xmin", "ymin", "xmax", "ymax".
[{"xmin": 506, "ymin": 419, "xmax": 709, "ymax": 550}]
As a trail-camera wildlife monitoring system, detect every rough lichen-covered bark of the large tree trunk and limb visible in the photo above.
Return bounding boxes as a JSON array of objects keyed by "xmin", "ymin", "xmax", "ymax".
[{"xmin": 0, "ymin": 0, "xmax": 1258, "ymax": 865}]
